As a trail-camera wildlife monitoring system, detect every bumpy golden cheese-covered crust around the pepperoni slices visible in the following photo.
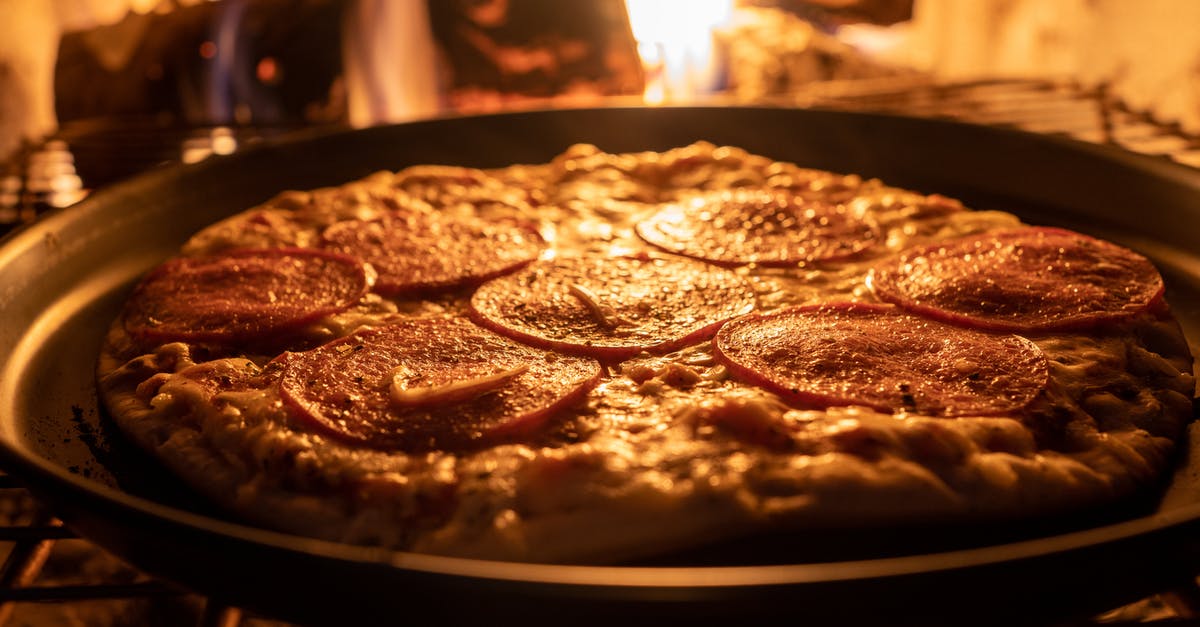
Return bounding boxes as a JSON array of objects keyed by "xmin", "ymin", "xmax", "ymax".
[{"xmin": 98, "ymin": 144, "xmax": 1194, "ymax": 563}]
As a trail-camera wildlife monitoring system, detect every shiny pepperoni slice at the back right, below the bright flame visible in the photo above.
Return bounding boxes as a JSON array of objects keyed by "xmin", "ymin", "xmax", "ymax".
[{"xmin": 637, "ymin": 183, "xmax": 880, "ymax": 267}]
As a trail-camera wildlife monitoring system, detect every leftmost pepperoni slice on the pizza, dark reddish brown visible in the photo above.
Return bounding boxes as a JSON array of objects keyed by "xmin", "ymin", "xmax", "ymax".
[{"xmin": 125, "ymin": 249, "xmax": 373, "ymax": 344}]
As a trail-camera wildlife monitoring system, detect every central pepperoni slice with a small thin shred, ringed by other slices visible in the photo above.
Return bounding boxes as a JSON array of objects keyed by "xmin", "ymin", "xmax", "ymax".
[{"xmin": 470, "ymin": 257, "xmax": 755, "ymax": 359}]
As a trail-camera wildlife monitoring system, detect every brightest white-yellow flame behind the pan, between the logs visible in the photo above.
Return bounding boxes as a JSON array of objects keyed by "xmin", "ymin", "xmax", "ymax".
[{"xmin": 625, "ymin": 0, "xmax": 734, "ymax": 105}]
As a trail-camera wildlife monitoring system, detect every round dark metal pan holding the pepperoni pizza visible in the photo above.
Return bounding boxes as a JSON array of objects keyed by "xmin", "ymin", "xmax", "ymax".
[{"xmin": 0, "ymin": 108, "xmax": 1200, "ymax": 625}]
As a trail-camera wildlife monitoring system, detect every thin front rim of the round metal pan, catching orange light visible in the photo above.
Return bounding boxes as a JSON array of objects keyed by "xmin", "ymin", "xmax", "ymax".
[{"xmin": 7, "ymin": 441, "xmax": 1200, "ymax": 589}]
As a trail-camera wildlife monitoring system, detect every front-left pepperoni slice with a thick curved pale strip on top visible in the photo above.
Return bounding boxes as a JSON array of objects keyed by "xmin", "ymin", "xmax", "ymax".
[{"xmin": 280, "ymin": 318, "xmax": 600, "ymax": 452}]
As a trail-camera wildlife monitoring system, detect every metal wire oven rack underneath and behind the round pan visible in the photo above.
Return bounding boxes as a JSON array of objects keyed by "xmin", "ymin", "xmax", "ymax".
[{"xmin": 0, "ymin": 77, "xmax": 1200, "ymax": 627}]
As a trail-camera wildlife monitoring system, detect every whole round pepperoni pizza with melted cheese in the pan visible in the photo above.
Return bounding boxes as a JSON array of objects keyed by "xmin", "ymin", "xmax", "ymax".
[{"xmin": 97, "ymin": 142, "xmax": 1195, "ymax": 563}]
